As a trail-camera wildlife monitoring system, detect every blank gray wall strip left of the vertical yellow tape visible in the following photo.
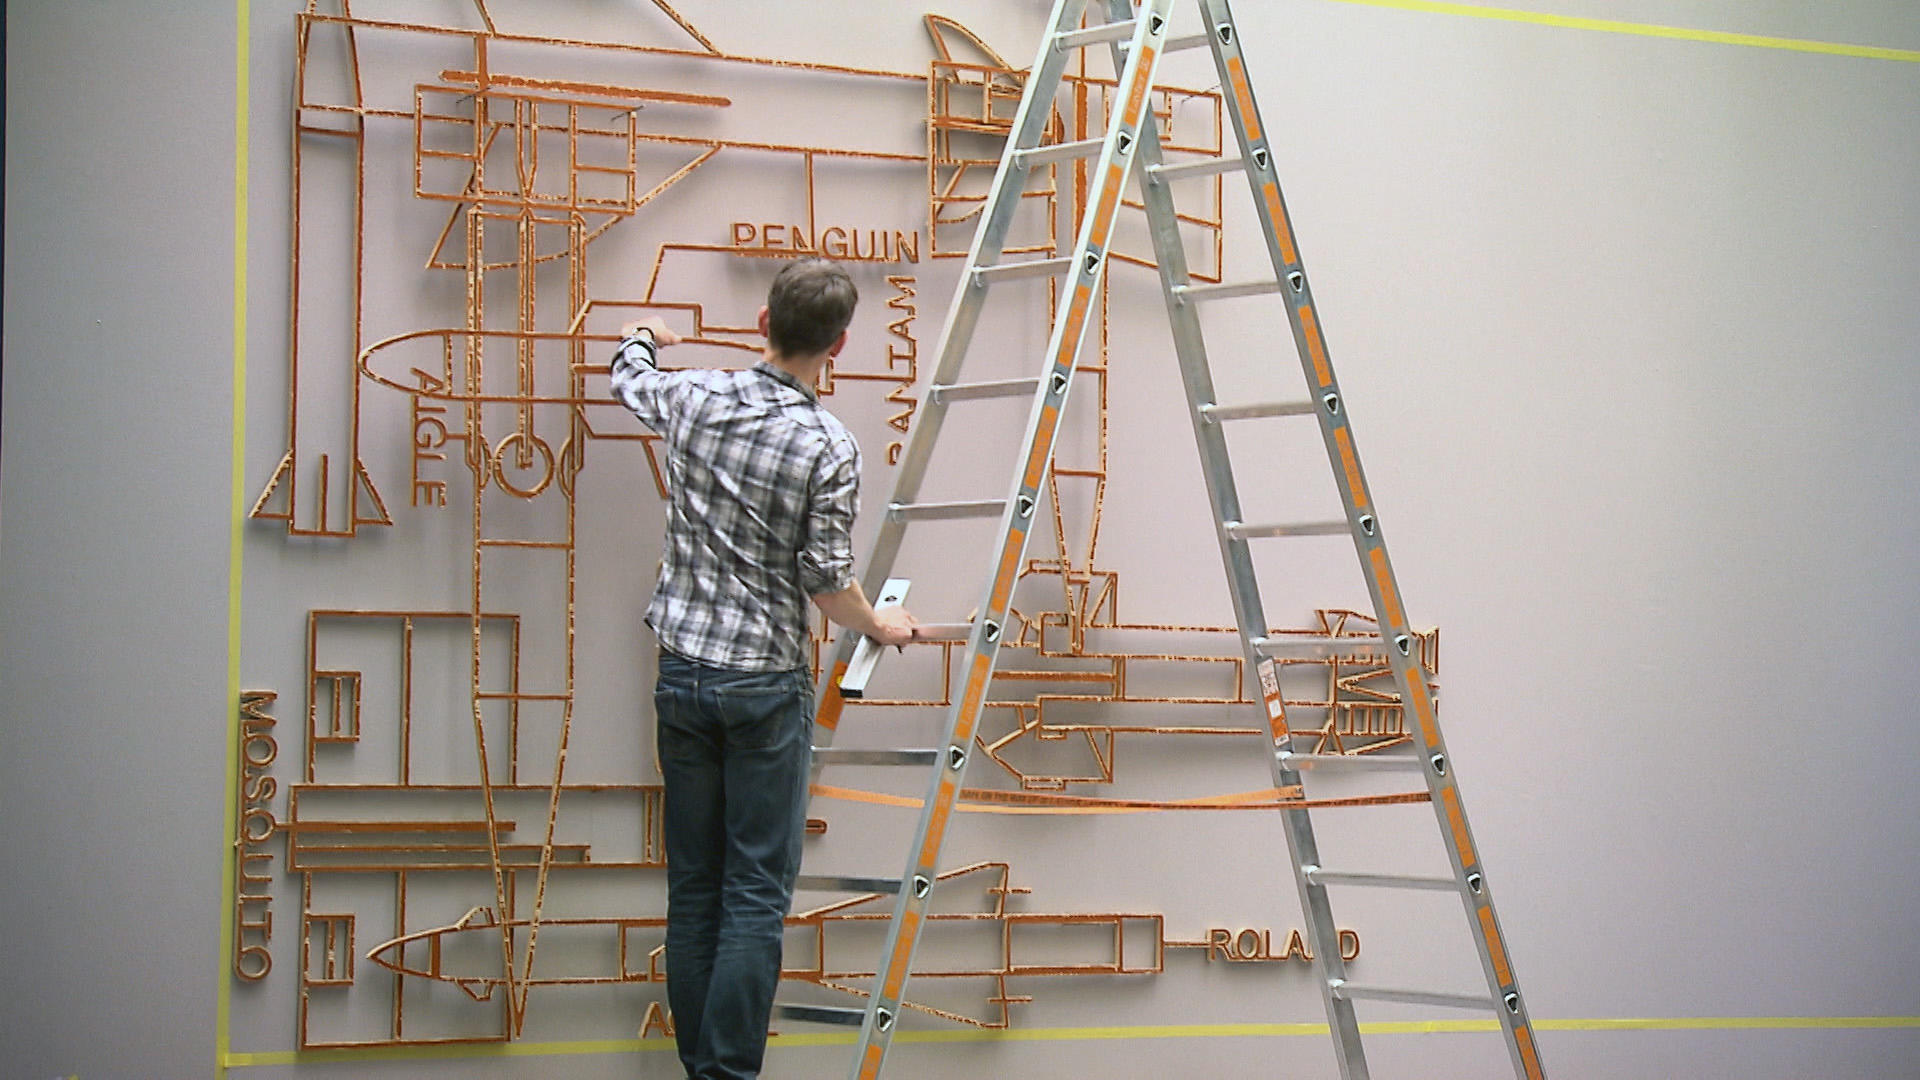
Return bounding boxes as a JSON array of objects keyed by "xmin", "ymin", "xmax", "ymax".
[{"xmin": 0, "ymin": 4, "xmax": 234, "ymax": 1080}]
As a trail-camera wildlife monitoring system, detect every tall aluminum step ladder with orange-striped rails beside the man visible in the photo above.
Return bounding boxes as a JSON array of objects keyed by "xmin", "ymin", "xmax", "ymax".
[{"xmin": 778, "ymin": 0, "xmax": 1546, "ymax": 1080}]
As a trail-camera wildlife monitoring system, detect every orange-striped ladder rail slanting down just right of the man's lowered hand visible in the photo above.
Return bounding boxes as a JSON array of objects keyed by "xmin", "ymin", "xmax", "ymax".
[{"xmin": 851, "ymin": 0, "xmax": 1173, "ymax": 1080}]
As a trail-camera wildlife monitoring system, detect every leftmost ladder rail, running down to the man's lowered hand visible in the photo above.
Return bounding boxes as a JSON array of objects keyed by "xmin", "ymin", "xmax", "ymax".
[{"xmin": 814, "ymin": 0, "xmax": 1087, "ymax": 730}]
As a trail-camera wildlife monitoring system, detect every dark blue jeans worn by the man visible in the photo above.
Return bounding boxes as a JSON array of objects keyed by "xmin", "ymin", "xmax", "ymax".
[{"xmin": 653, "ymin": 650, "xmax": 814, "ymax": 1080}]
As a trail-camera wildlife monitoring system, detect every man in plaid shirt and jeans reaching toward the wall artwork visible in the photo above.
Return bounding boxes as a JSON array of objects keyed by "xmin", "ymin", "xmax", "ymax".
[{"xmin": 612, "ymin": 259, "xmax": 914, "ymax": 1080}]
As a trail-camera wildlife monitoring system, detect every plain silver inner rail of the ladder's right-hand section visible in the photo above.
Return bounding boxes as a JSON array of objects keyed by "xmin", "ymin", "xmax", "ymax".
[{"xmin": 1112, "ymin": 21, "xmax": 1369, "ymax": 1080}]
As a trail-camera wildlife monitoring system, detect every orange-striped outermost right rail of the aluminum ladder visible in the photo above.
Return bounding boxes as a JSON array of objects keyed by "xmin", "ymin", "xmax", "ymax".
[{"xmin": 1198, "ymin": 0, "xmax": 1546, "ymax": 1080}]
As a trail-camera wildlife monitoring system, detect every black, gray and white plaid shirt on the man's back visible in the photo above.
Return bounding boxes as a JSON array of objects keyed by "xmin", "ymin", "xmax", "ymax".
[{"xmin": 612, "ymin": 334, "xmax": 860, "ymax": 671}]
